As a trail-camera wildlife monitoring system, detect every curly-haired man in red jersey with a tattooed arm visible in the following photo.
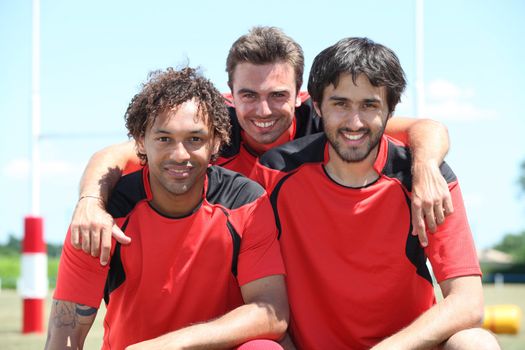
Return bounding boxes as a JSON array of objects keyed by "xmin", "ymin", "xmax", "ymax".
[{"xmin": 46, "ymin": 68, "xmax": 288, "ymax": 349}]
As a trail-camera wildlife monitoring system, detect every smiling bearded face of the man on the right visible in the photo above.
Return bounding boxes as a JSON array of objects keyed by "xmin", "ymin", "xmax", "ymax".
[{"xmin": 314, "ymin": 74, "xmax": 389, "ymax": 163}]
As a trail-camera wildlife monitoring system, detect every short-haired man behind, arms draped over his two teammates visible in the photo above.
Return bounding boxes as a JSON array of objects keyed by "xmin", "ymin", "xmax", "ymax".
[{"xmin": 71, "ymin": 27, "xmax": 453, "ymax": 264}]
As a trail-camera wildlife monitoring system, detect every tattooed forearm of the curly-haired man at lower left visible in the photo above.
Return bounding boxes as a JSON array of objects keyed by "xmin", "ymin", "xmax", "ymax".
[{"xmin": 45, "ymin": 300, "xmax": 97, "ymax": 350}]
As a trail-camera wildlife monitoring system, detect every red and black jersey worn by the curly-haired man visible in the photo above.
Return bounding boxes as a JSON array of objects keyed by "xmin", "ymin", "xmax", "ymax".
[{"xmin": 54, "ymin": 166, "xmax": 284, "ymax": 349}]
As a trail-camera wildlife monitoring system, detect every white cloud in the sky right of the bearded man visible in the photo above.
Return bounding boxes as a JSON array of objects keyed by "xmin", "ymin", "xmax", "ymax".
[{"xmin": 424, "ymin": 79, "xmax": 498, "ymax": 122}]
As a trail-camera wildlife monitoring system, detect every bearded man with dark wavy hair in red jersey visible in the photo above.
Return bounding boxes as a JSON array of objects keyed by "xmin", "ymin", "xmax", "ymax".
[{"xmin": 257, "ymin": 38, "xmax": 499, "ymax": 350}]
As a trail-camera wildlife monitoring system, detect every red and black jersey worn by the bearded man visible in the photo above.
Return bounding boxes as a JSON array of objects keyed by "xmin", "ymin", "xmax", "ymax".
[{"xmin": 257, "ymin": 133, "xmax": 481, "ymax": 349}]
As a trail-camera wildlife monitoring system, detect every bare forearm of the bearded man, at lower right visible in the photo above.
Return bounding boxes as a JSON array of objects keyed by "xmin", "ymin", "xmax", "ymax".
[{"xmin": 373, "ymin": 276, "xmax": 483, "ymax": 350}]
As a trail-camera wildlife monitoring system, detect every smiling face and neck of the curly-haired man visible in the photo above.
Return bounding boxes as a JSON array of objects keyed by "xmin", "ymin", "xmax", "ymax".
[{"xmin": 137, "ymin": 100, "xmax": 219, "ymax": 215}]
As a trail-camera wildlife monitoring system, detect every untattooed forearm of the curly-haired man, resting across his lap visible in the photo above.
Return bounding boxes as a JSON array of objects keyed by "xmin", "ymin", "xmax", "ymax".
[{"xmin": 128, "ymin": 303, "xmax": 288, "ymax": 350}]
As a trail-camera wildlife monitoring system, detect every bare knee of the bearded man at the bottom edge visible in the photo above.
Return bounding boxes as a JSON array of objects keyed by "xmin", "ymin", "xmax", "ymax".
[{"xmin": 441, "ymin": 328, "xmax": 501, "ymax": 350}]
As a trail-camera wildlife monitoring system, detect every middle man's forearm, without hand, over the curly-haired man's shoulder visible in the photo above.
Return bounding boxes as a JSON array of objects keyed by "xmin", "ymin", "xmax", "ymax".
[{"xmin": 79, "ymin": 142, "xmax": 138, "ymax": 203}]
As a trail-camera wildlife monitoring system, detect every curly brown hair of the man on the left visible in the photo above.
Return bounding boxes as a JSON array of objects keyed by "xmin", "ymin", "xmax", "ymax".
[{"xmin": 124, "ymin": 67, "xmax": 231, "ymax": 163}]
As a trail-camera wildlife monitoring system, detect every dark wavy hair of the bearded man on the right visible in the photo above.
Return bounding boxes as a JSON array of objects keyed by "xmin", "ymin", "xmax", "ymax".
[{"xmin": 308, "ymin": 38, "xmax": 406, "ymax": 113}]
